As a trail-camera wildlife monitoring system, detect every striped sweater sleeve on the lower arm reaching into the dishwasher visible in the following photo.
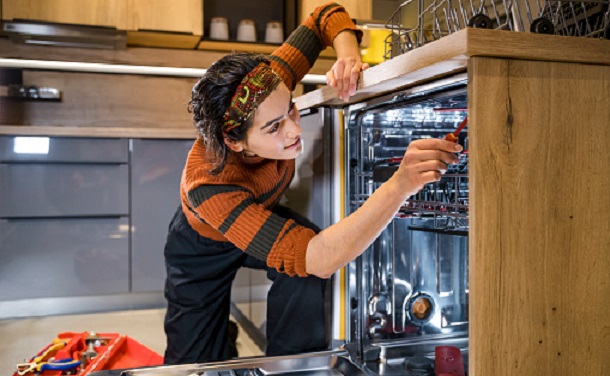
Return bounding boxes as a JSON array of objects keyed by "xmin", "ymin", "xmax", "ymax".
[{"xmin": 187, "ymin": 185, "xmax": 315, "ymax": 276}]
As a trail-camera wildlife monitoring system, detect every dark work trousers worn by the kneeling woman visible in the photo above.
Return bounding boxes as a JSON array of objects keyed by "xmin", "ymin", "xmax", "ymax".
[{"xmin": 159, "ymin": 207, "xmax": 328, "ymax": 364}]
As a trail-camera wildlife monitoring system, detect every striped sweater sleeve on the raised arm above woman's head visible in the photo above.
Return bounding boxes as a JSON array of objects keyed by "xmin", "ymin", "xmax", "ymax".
[{"xmin": 270, "ymin": 3, "xmax": 362, "ymax": 90}]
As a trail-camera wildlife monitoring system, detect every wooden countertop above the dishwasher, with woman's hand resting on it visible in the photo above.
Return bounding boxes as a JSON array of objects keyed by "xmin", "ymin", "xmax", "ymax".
[{"xmin": 295, "ymin": 28, "xmax": 610, "ymax": 109}]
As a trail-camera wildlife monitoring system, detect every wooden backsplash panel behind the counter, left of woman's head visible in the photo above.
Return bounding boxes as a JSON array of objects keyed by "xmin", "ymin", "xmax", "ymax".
[{"xmin": 12, "ymin": 71, "xmax": 192, "ymax": 129}]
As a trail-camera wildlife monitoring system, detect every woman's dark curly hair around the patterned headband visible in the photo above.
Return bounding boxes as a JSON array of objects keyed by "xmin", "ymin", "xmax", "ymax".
[{"xmin": 189, "ymin": 53, "xmax": 268, "ymax": 175}]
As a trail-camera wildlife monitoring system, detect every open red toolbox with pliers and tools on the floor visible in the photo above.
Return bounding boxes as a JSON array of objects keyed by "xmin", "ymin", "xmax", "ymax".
[{"xmin": 13, "ymin": 332, "xmax": 163, "ymax": 376}]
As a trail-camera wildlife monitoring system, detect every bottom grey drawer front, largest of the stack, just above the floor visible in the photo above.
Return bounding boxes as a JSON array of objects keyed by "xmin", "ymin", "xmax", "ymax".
[{"xmin": 0, "ymin": 218, "xmax": 129, "ymax": 301}]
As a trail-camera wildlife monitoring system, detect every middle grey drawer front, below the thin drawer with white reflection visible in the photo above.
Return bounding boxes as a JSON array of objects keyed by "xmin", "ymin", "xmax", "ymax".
[{"xmin": 0, "ymin": 163, "xmax": 129, "ymax": 218}]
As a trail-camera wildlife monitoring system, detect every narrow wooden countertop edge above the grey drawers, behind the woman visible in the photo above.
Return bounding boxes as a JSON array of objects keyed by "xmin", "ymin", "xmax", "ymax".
[{"xmin": 0, "ymin": 125, "xmax": 197, "ymax": 140}]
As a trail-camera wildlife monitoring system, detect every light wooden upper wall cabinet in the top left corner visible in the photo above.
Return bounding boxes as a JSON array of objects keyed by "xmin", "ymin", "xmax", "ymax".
[{"xmin": 2, "ymin": 0, "xmax": 203, "ymax": 36}]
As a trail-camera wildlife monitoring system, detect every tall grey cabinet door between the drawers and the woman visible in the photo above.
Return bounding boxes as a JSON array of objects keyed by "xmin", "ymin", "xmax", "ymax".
[{"xmin": 131, "ymin": 140, "xmax": 193, "ymax": 292}]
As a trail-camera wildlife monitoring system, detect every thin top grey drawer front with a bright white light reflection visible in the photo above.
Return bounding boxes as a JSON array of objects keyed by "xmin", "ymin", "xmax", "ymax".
[{"xmin": 0, "ymin": 136, "xmax": 129, "ymax": 163}]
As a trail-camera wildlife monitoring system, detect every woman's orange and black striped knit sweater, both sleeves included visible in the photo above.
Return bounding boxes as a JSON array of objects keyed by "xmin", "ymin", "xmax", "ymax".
[{"xmin": 180, "ymin": 3, "xmax": 361, "ymax": 276}]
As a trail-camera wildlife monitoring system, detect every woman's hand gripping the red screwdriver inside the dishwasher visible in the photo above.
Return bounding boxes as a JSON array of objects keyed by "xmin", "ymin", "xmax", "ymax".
[{"xmin": 394, "ymin": 138, "xmax": 462, "ymax": 196}]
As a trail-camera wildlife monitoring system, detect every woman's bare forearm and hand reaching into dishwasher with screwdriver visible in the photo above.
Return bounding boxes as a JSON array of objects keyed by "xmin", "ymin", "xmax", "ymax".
[{"xmin": 305, "ymin": 139, "xmax": 462, "ymax": 278}]
